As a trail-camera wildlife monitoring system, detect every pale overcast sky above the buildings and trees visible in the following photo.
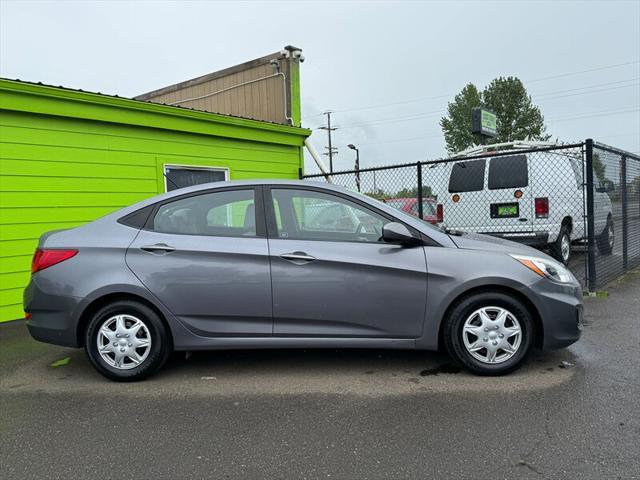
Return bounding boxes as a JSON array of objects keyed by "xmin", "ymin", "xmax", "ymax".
[{"xmin": 0, "ymin": 0, "xmax": 640, "ymax": 172}]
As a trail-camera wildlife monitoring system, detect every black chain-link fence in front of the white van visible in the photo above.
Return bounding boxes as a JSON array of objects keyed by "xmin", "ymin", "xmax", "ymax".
[{"xmin": 302, "ymin": 140, "xmax": 640, "ymax": 291}]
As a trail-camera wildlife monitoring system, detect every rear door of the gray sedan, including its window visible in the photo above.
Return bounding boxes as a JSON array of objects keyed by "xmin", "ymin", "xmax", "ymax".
[{"xmin": 126, "ymin": 187, "xmax": 272, "ymax": 336}]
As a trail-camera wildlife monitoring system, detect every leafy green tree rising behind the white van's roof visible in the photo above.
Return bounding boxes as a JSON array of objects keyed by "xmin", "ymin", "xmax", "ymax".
[{"xmin": 440, "ymin": 77, "xmax": 551, "ymax": 153}]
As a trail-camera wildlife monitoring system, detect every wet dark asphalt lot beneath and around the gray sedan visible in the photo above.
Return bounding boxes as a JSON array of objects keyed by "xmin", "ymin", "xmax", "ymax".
[{"xmin": 0, "ymin": 270, "xmax": 640, "ymax": 479}]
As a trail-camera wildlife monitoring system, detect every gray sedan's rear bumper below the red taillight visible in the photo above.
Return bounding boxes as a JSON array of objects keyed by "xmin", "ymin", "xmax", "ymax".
[{"xmin": 23, "ymin": 279, "xmax": 81, "ymax": 347}]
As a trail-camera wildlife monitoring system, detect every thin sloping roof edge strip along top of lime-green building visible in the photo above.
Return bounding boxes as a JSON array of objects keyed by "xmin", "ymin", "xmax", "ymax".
[{"xmin": 0, "ymin": 77, "xmax": 311, "ymax": 136}]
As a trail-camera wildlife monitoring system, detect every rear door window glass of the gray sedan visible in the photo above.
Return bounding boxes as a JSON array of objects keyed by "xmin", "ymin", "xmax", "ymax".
[{"xmin": 153, "ymin": 190, "xmax": 256, "ymax": 237}]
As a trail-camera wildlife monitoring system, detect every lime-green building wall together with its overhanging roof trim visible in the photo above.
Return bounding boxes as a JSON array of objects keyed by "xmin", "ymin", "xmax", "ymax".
[{"xmin": 0, "ymin": 80, "xmax": 310, "ymax": 321}]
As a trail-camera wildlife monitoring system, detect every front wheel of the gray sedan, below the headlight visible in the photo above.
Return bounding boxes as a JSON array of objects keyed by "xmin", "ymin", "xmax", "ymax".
[{"xmin": 443, "ymin": 291, "xmax": 535, "ymax": 376}]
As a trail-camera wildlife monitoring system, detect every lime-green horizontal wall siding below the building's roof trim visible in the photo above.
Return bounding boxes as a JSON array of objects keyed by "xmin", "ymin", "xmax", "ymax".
[{"xmin": 0, "ymin": 84, "xmax": 308, "ymax": 321}]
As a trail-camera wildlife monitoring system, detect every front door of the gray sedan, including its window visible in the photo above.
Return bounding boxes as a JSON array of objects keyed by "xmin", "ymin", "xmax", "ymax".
[{"xmin": 265, "ymin": 186, "xmax": 427, "ymax": 338}]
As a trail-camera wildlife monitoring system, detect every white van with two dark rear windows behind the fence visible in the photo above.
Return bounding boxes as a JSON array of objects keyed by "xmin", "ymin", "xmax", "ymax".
[{"xmin": 435, "ymin": 150, "xmax": 614, "ymax": 264}]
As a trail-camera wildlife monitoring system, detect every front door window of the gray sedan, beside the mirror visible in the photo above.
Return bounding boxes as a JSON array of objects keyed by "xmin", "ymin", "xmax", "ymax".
[{"xmin": 271, "ymin": 188, "xmax": 388, "ymax": 242}]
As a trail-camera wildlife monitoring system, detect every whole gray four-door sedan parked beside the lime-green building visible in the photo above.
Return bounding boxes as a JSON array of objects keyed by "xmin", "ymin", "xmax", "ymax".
[{"xmin": 24, "ymin": 181, "xmax": 582, "ymax": 381}]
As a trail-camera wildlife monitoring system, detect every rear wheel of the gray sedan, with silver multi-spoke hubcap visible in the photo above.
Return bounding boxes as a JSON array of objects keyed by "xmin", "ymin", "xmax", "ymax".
[{"xmin": 84, "ymin": 300, "xmax": 173, "ymax": 382}]
